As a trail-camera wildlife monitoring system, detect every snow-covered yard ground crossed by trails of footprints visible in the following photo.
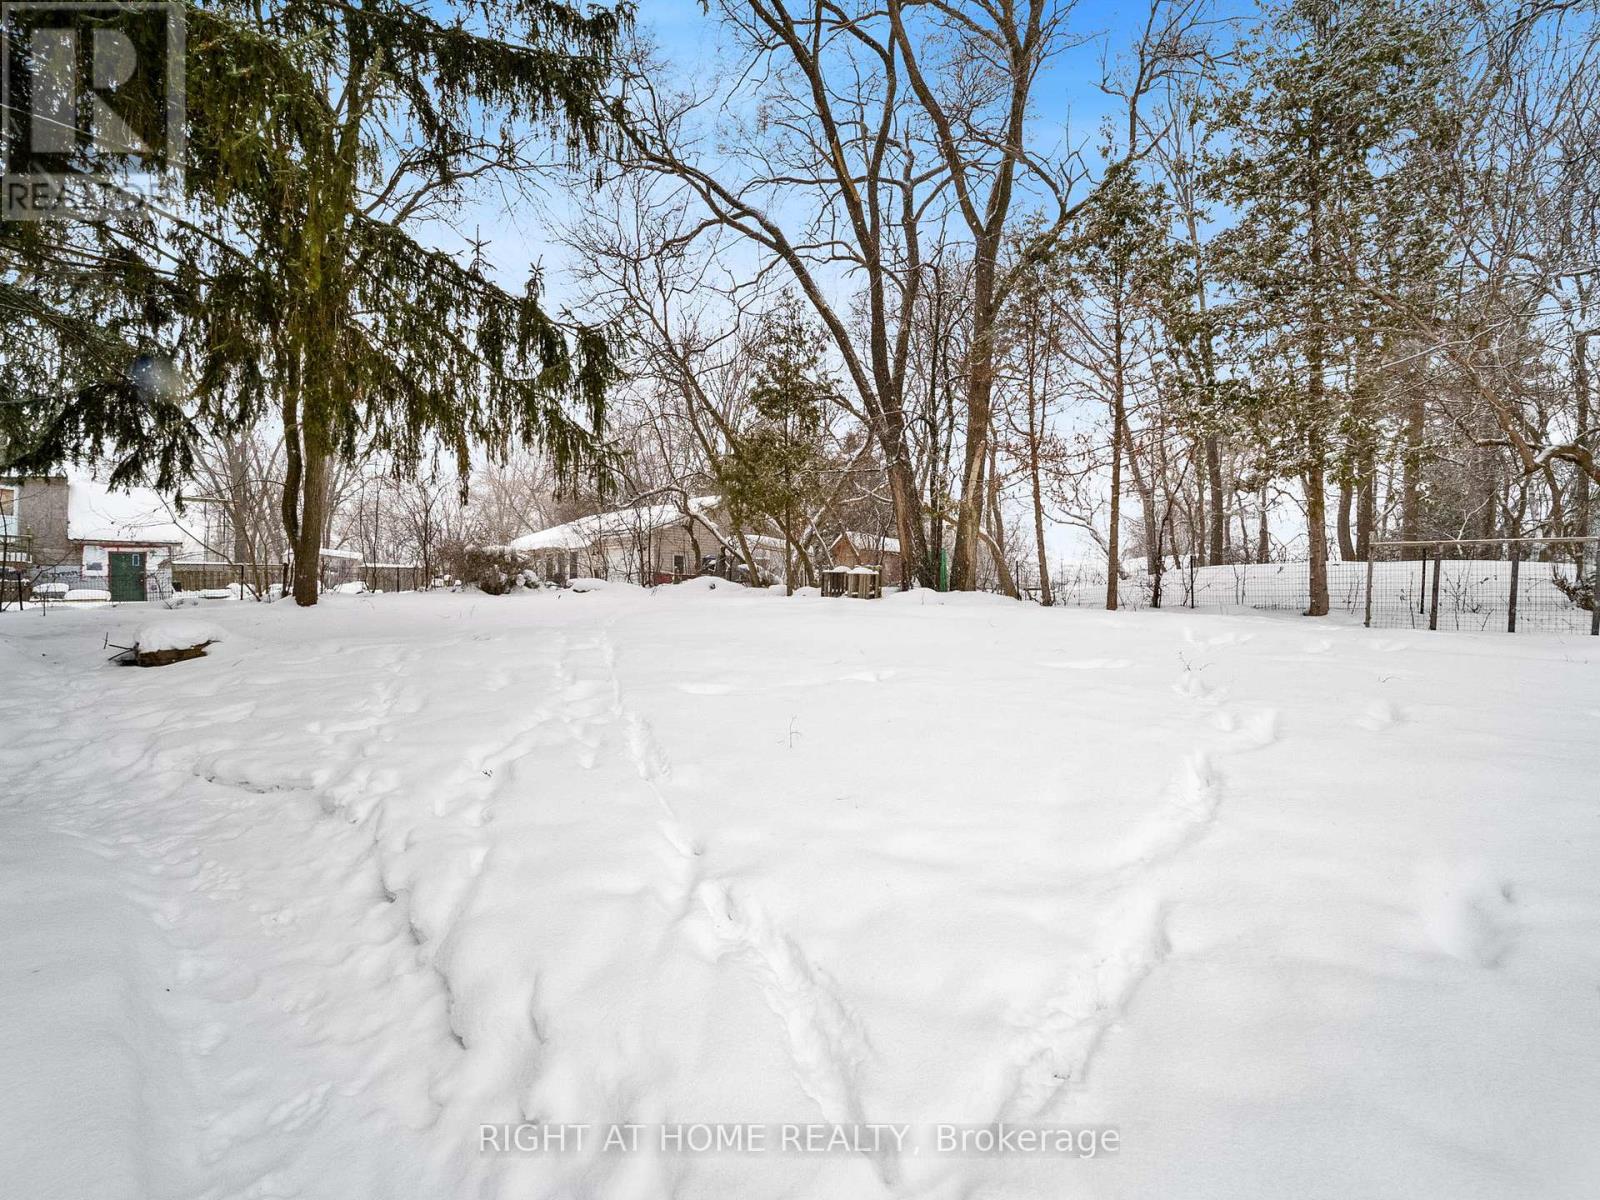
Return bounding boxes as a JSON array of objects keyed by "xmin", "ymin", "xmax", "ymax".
[{"xmin": 0, "ymin": 587, "xmax": 1600, "ymax": 1200}]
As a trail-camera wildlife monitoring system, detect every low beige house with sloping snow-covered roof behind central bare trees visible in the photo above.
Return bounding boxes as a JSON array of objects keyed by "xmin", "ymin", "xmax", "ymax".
[{"xmin": 506, "ymin": 496, "xmax": 733, "ymax": 584}]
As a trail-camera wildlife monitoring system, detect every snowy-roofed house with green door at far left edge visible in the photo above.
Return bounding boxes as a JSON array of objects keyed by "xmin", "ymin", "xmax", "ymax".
[{"xmin": 0, "ymin": 475, "xmax": 230, "ymax": 600}]
